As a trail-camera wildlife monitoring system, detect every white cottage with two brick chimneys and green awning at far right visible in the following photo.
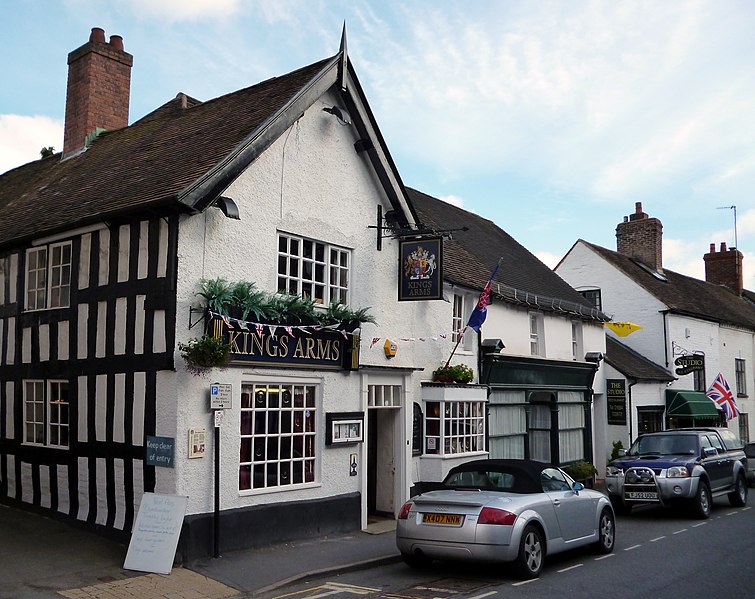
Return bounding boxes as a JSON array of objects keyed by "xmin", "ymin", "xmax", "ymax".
[{"xmin": 556, "ymin": 202, "xmax": 755, "ymax": 448}]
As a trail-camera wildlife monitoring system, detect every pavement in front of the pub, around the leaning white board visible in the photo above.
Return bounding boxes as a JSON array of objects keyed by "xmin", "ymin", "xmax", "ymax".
[{"xmin": 0, "ymin": 505, "xmax": 401, "ymax": 599}]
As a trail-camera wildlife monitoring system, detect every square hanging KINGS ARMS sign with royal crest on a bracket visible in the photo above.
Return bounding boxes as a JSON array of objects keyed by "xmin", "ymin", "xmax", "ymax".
[{"xmin": 398, "ymin": 237, "xmax": 443, "ymax": 302}]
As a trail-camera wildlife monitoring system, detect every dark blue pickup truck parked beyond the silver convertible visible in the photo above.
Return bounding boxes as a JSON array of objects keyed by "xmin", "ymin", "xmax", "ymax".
[{"xmin": 606, "ymin": 428, "xmax": 747, "ymax": 518}]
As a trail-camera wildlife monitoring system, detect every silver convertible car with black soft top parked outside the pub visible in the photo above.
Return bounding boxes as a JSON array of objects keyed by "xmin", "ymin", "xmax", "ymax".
[{"xmin": 396, "ymin": 460, "xmax": 616, "ymax": 578}]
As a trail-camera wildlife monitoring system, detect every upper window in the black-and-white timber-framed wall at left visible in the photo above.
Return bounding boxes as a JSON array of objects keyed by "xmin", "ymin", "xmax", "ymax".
[{"xmin": 25, "ymin": 241, "xmax": 72, "ymax": 310}]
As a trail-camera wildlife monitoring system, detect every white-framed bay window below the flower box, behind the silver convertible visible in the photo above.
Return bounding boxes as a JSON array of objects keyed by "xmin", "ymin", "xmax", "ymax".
[{"xmin": 425, "ymin": 401, "xmax": 485, "ymax": 455}]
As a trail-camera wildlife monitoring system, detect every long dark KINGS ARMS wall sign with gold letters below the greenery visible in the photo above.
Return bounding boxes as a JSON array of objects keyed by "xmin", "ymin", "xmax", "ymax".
[{"xmin": 208, "ymin": 315, "xmax": 359, "ymax": 370}]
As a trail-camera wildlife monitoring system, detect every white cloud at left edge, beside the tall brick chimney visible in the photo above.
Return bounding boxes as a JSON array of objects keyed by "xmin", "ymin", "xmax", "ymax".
[{"xmin": 0, "ymin": 114, "xmax": 63, "ymax": 173}]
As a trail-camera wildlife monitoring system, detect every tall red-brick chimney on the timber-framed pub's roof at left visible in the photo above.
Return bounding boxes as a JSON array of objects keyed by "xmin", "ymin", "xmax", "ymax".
[{"xmin": 63, "ymin": 27, "xmax": 134, "ymax": 158}]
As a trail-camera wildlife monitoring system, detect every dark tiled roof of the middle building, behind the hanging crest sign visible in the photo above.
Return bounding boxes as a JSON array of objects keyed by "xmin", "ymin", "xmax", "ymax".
[{"xmin": 407, "ymin": 188, "xmax": 608, "ymax": 321}]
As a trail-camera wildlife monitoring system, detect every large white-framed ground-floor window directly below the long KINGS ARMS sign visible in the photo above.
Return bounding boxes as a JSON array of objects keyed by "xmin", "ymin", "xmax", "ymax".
[{"xmin": 239, "ymin": 382, "xmax": 319, "ymax": 491}]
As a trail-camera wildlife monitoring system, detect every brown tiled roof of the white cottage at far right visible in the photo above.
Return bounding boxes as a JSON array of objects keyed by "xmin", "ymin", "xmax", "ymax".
[{"xmin": 578, "ymin": 240, "xmax": 755, "ymax": 329}]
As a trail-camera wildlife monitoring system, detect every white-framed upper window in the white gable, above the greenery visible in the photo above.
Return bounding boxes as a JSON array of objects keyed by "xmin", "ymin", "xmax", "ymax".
[{"xmin": 278, "ymin": 233, "xmax": 351, "ymax": 306}]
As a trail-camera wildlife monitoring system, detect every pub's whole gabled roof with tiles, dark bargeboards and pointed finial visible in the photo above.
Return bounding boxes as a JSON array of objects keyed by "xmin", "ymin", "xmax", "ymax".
[{"xmin": 0, "ymin": 36, "xmax": 414, "ymax": 248}]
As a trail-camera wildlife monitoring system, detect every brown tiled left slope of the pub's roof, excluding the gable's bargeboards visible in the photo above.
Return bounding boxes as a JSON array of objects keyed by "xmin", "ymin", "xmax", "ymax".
[{"xmin": 0, "ymin": 58, "xmax": 333, "ymax": 247}]
